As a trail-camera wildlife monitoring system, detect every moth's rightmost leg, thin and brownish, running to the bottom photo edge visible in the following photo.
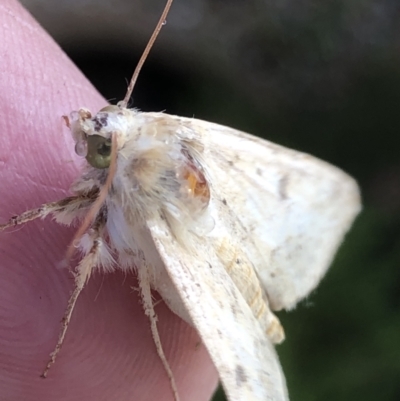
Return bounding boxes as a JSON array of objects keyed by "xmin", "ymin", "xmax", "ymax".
[{"xmin": 138, "ymin": 265, "xmax": 179, "ymax": 401}]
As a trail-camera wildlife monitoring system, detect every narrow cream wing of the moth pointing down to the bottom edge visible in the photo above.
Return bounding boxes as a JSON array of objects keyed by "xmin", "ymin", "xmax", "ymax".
[{"xmin": 146, "ymin": 219, "xmax": 288, "ymax": 401}]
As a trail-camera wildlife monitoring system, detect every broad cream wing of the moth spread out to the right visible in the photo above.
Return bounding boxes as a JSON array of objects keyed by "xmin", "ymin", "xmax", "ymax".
[{"xmin": 175, "ymin": 117, "xmax": 361, "ymax": 310}]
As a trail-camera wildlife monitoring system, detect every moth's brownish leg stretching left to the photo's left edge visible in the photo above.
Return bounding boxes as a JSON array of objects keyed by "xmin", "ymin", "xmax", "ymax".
[{"xmin": 0, "ymin": 193, "xmax": 95, "ymax": 231}]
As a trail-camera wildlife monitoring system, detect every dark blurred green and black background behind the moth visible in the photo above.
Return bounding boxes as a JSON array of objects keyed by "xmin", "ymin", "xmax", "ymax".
[{"xmin": 22, "ymin": 0, "xmax": 400, "ymax": 401}]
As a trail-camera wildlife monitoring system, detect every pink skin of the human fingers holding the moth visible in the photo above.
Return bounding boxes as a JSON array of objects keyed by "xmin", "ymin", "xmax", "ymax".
[{"xmin": 0, "ymin": 0, "xmax": 217, "ymax": 401}]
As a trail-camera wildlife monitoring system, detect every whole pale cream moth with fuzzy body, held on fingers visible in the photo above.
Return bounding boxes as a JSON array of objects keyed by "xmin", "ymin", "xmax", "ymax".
[{"xmin": 0, "ymin": 0, "xmax": 360, "ymax": 401}]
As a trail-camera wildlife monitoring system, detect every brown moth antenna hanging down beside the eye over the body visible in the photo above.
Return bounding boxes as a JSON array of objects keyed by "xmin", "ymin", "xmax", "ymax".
[{"xmin": 65, "ymin": 134, "xmax": 117, "ymax": 263}]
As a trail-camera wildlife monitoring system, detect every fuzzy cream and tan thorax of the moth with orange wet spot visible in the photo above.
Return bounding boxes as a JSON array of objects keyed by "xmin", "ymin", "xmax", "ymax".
[{"xmin": 71, "ymin": 106, "xmax": 213, "ymax": 266}]
